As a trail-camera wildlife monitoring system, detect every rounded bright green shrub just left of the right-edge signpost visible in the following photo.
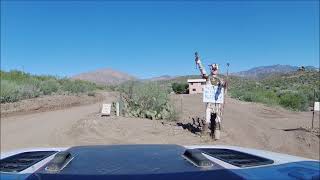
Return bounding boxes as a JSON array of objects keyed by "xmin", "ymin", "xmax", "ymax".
[{"xmin": 279, "ymin": 92, "xmax": 308, "ymax": 111}]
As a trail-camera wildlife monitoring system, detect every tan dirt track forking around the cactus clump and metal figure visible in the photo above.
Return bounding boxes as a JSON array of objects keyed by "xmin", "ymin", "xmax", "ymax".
[{"xmin": 1, "ymin": 94, "xmax": 319, "ymax": 159}]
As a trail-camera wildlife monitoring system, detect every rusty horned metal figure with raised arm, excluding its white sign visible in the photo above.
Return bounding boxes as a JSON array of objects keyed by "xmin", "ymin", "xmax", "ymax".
[{"xmin": 195, "ymin": 52, "xmax": 226, "ymax": 140}]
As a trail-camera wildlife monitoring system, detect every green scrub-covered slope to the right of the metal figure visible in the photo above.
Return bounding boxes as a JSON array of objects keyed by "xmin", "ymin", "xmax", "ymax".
[{"xmin": 229, "ymin": 71, "xmax": 320, "ymax": 111}]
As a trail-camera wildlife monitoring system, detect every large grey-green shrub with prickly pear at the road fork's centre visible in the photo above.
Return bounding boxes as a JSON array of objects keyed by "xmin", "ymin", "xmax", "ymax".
[{"xmin": 119, "ymin": 82, "xmax": 177, "ymax": 120}]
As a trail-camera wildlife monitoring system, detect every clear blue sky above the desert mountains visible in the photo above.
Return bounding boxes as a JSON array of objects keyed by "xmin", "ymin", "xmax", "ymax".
[{"xmin": 1, "ymin": 0, "xmax": 319, "ymax": 78}]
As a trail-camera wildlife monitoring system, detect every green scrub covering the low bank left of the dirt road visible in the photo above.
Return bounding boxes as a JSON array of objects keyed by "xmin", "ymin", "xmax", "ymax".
[{"xmin": 0, "ymin": 70, "xmax": 104, "ymax": 103}]
